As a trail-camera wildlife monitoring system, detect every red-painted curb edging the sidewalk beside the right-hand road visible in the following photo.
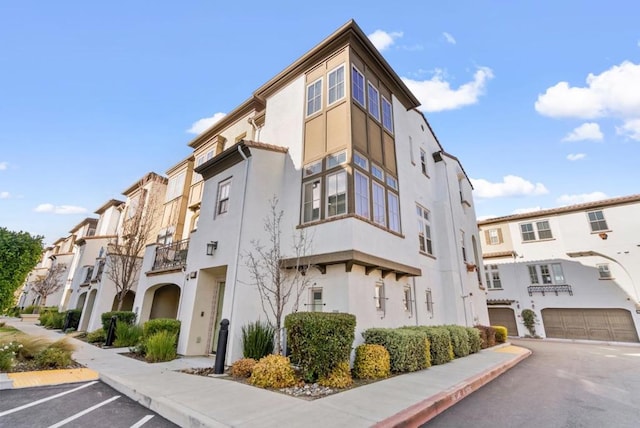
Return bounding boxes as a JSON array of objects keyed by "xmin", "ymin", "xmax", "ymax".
[{"xmin": 374, "ymin": 348, "xmax": 531, "ymax": 428}]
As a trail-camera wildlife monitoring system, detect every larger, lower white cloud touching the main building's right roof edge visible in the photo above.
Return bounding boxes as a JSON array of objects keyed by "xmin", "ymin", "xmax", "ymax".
[{"xmin": 402, "ymin": 67, "xmax": 493, "ymax": 112}]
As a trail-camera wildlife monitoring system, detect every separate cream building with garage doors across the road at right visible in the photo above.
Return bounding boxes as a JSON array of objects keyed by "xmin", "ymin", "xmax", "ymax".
[{"xmin": 478, "ymin": 195, "xmax": 640, "ymax": 342}]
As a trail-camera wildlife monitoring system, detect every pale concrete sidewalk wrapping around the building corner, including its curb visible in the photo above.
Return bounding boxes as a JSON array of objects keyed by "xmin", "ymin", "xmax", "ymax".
[{"xmin": 3, "ymin": 319, "xmax": 531, "ymax": 427}]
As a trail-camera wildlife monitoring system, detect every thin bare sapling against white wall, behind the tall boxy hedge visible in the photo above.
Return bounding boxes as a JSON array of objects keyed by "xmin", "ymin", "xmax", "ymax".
[{"xmin": 245, "ymin": 196, "xmax": 311, "ymax": 354}]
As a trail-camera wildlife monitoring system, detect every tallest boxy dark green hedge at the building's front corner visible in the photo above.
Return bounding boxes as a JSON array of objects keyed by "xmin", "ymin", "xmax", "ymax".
[{"xmin": 284, "ymin": 312, "xmax": 356, "ymax": 382}]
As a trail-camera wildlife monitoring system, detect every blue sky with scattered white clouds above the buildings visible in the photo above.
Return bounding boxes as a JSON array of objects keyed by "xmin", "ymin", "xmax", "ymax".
[{"xmin": 0, "ymin": 0, "xmax": 640, "ymax": 243}]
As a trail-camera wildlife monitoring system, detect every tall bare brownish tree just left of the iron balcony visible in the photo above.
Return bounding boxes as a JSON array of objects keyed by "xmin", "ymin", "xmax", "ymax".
[{"xmin": 106, "ymin": 173, "xmax": 164, "ymax": 311}]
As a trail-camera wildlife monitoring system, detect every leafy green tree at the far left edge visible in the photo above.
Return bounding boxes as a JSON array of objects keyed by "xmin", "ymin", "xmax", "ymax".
[{"xmin": 0, "ymin": 227, "xmax": 43, "ymax": 312}]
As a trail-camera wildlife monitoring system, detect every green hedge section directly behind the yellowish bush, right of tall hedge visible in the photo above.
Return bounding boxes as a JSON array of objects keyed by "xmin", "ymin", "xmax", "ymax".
[{"xmin": 362, "ymin": 328, "xmax": 431, "ymax": 373}]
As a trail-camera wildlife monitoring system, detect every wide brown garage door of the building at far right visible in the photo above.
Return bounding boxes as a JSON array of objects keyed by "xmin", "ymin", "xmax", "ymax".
[{"xmin": 542, "ymin": 308, "xmax": 638, "ymax": 342}]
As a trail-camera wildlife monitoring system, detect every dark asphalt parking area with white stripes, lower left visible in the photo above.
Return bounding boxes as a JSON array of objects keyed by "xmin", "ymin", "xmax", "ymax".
[{"xmin": 0, "ymin": 381, "xmax": 177, "ymax": 428}]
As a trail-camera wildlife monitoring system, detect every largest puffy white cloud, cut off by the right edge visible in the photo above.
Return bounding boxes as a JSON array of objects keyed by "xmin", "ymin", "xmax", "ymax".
[{"xmin": 535, "ymin": 61, "xmax": 640, "ymax": 119}]
